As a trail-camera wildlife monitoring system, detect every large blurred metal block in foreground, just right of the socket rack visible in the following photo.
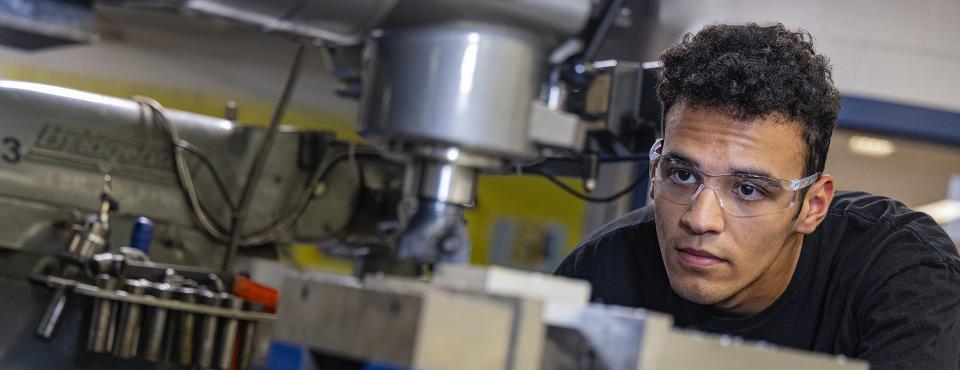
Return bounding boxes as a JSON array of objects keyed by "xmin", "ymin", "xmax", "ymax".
[{"xmin": 274, "ymin": 278, "xmax": 513, "ymax": 370}]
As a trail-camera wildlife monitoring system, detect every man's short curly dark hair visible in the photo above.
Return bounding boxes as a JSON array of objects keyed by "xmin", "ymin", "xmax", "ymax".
[{"xmin": 657, "ymin": 23, "xmax": 840, "ymax": 175}]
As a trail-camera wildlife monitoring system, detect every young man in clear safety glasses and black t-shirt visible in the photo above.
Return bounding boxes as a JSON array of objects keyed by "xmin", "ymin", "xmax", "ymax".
[{"xmin": 557, "ymin": 24, "xmax": 960, "ymax": 369}]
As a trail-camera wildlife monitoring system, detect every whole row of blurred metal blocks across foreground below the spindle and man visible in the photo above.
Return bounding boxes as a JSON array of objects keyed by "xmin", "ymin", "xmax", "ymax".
[{"xmin": 274, "ymin": 266, "xmax": 867, "ymax": 370}]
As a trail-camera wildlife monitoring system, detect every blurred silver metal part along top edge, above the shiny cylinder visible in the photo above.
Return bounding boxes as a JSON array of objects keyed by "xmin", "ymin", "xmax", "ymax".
[{"xmin": 105, "ymin": 0, "xmax": 590, "ymax": 45}]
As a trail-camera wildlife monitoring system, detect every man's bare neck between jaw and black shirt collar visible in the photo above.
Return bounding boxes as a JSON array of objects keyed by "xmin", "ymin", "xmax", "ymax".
[{"xmin": 712, "ymin": 234, "xmax": 803, "ymax": 317}]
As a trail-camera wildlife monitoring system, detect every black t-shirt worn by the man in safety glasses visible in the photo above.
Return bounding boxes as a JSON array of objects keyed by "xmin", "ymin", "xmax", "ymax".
[{"xmin": 556, "ymin": 193, "xmax": 960, "ymax": 369}]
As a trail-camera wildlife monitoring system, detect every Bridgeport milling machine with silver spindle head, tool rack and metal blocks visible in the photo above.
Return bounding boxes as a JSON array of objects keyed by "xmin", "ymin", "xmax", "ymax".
[{"xmin": 0, "ymin": 0, "xmax": 865, "ymax": 369}]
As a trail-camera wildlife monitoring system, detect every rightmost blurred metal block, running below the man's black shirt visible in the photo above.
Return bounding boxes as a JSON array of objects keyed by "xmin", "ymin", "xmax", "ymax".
[{"xmin": 542, "ymin": 304, "xmax": 867, "ymax": 370}]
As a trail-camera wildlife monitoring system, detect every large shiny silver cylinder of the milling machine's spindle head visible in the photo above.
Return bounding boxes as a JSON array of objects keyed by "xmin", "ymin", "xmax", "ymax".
[{"xmin": 358, "ymin": 25, "xmax": 548, "ymax": 158}]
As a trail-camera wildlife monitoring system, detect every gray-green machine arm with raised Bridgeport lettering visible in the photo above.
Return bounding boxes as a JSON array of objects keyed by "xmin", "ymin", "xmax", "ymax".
[{"xmin": 0, "ymin": 81, "xmax": 357, "ymax": 266}]
